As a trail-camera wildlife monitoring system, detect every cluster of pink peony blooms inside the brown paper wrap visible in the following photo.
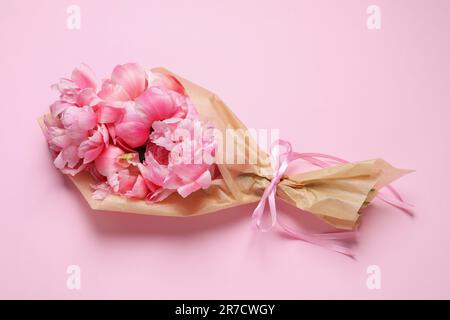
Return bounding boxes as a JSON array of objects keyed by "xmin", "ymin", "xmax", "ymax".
[{"xmin": 45, "ymin": 63, "xmax": 216, "ymax": 202}]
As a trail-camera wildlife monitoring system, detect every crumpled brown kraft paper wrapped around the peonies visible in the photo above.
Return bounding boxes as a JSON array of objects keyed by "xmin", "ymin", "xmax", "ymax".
[{"xmin": 39, "ymin": 68, "xmax": 410, "ymax": 230}]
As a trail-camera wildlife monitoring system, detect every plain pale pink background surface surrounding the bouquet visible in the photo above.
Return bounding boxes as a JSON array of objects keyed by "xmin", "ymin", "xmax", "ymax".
[{"xmin": 0, "ymin": 0, "xmax": 450, "ymax": 299}]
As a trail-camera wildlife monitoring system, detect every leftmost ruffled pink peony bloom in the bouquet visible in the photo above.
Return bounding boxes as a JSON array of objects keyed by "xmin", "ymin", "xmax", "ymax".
[{"xmin": 46, "ymin": 65, "xmax": 109, "ymax": 175}]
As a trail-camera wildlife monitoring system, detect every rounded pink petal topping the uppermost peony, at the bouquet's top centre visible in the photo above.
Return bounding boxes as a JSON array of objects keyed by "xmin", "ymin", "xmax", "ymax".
[{"xmin": 111, "ymin": 63, "xmax": 147, "ymax": 99}]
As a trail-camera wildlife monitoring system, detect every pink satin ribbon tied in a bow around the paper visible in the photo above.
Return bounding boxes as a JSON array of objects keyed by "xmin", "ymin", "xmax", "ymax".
[{"xmin": 252, "ymin": 140, "xmax": 413, "ymax": 257}]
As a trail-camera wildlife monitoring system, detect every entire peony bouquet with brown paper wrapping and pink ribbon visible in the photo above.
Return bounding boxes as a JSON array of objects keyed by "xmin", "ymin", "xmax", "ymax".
[{"xmin": 40, "ymin": 63, "xmax": 410, "ymax": 255}]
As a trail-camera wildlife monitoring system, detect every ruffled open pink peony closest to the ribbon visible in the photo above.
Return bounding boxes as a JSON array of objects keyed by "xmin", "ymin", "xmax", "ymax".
[{"xmin": 138, "ymin": 119, "xmax": 216, "ymax": 201}]
